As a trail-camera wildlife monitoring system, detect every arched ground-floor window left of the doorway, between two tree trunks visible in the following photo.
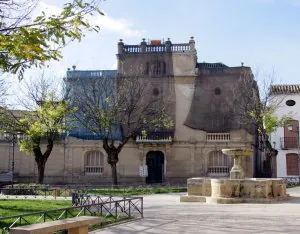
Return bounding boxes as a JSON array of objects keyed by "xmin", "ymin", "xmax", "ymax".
[{"xmin": 84, "ymin": 151, "xmax": 104, "ymax": 175}]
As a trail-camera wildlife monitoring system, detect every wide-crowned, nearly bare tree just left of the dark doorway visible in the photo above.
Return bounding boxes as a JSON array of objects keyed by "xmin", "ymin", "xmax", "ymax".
[{"xmin": 70, "ymin": 77, "xmax": 173, "ymax": 185}]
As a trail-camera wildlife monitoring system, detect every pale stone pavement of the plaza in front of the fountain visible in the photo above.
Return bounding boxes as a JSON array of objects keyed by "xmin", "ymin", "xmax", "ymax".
[{"xmin": 90, "ymin": 187, "xmax": 300, "ymax": 234}]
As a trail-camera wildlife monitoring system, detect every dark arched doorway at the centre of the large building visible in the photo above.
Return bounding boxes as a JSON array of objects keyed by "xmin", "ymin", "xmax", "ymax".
[{"xmin": 146, "ymin": 151, "xmax": 165, "ymax": 184}]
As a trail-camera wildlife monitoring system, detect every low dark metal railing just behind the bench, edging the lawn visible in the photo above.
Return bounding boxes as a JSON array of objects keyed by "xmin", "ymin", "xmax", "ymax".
[{"xmin": 0, "ymin": 194, "xmax": 143, "ymax": 234}]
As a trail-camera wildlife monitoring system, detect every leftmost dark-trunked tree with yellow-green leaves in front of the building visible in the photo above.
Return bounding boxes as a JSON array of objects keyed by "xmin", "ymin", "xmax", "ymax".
[{"xmin": 2, "ymin": 75, "xmax": 72, "ymax": 183}]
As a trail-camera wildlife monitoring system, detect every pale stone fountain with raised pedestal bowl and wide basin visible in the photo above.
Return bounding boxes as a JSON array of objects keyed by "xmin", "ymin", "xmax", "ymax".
[{"xmin": 180, "ymin": 148, "xmax": 288, "ymax": 204}]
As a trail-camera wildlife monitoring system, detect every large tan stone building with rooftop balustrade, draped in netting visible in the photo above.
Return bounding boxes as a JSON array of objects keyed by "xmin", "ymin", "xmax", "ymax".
[{"xmin": 0, "ymin": 38, "xmax": 257, "ymax": 184}]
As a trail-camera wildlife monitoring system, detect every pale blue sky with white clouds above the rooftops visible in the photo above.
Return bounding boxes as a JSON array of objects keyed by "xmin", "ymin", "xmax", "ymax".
[{"xmin": 18, "ymin": 0, "xmax": 300, "ymax": 83}]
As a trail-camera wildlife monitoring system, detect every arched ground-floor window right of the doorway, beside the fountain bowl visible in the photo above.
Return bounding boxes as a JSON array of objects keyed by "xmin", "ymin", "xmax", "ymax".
[{"xmin": 208, "ymin": 151, "xmax": 232, "ymax": 176}]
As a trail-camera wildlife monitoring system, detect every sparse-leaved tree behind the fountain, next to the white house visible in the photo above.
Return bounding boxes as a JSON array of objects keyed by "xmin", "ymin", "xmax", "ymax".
[{"xmin": 236, "ymin": 72, "xmax": 291, "ymax": 177}]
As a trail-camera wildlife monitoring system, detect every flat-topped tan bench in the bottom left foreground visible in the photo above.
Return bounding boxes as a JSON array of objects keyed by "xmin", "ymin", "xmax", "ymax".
[{"xmin": 10, "ymin": 216, "xmax": 101, "ymax": 234}]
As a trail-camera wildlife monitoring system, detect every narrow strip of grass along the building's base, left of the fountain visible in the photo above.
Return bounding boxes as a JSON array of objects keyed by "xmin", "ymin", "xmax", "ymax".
[{"xmin": 85, "ymin": 187, "xmax": 187, "ymax": 196}]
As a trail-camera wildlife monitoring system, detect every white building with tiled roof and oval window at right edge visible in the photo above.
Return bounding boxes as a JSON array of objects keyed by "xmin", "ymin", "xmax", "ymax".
[{"xmin": 270, "ymin": 84, "xmax": 300, "ymax": 180}]
